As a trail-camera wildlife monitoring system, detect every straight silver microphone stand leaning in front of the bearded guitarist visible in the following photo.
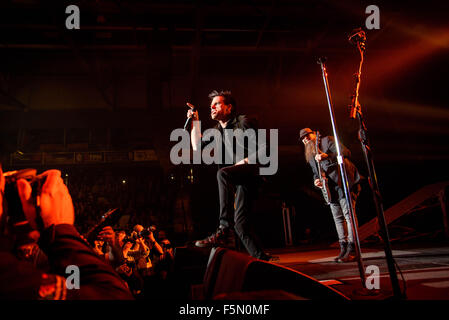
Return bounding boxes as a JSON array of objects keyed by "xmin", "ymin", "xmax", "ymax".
[{"xmin": 318, "ymin": 58, "xmax": 366, "ymax": 290}]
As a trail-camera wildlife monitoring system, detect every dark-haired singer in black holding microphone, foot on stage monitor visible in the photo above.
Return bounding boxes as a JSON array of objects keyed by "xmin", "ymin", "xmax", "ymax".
[{"xmin": 186, "ymin": 90, "xmax": 272, "ymax": 261}]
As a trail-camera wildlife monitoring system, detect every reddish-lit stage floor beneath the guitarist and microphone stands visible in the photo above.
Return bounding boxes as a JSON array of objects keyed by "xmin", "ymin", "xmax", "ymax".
[{"xmin": 267, "ymin": 243, "xmax": 449, "ymax": 300}]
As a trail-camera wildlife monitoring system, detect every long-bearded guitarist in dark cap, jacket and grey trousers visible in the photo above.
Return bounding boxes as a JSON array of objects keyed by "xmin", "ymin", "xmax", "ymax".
[{"xmin": 299, "ymin": 128, "xmax": 362, "ymax": 262}]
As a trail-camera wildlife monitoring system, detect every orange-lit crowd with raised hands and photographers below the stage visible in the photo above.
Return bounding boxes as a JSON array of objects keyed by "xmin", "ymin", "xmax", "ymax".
[{"xmin": 0, "ymin": 167, "xmax": 178, "ymax": 300}]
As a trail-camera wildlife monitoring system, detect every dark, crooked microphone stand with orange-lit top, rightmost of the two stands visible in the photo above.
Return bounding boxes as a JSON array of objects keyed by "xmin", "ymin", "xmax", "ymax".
[{"xmin": 349, "ymin": 29, "xmax": 405, "ymax": 299}]
